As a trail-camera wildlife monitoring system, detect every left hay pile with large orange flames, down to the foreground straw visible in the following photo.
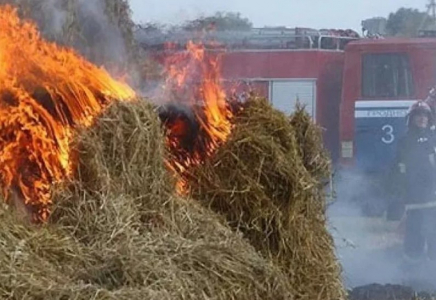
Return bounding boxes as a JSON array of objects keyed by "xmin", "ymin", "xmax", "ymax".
[{"xmin": 0, "ymin": 6, "xmax": 293, "ymax": 300}]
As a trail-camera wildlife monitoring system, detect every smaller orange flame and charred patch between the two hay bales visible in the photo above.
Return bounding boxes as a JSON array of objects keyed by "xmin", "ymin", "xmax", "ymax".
[{"xmin": 160, "ymin": 42, "xmax": 238, "ymax": 193}]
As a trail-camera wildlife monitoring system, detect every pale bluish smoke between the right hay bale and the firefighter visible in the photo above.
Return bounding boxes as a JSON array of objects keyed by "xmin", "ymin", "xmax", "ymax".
[{"xmin": 327, "ymin": 173, "xmax": 436, "ymax": 291}]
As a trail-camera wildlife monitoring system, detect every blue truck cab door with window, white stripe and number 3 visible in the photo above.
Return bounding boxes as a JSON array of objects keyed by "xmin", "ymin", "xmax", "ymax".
[{"xmin": 354, "ymin": 53, "xmax": 416, "ymax": 173}]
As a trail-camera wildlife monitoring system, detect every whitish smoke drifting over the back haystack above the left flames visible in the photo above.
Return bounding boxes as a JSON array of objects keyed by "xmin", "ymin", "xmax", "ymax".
[{"xmin": 20, "ymin": 0, "xmax": 136, "ymax": 77}]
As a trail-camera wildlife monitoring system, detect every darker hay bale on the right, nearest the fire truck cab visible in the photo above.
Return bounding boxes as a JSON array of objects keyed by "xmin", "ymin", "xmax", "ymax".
[{"xmin": 189, "ymin": 98, "xmax": 345, "ymax": 299}]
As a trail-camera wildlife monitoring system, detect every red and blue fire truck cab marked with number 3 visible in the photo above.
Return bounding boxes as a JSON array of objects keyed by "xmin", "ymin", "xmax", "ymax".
[{"xmin": 340, "ymin": 38, "xmax": 436, "ymax": 173}]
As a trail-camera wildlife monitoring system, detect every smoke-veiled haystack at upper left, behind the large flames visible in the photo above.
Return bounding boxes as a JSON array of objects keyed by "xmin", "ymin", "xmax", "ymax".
[{"xmin": 16, "ymin": 0, "xmax": 139, "ymax": 82}]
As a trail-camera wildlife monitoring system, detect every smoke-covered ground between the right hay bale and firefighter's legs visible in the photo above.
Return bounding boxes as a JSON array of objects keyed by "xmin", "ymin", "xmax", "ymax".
[{"xmin": 328, "ymin": 202, "xmax": 436, "ymax": 291}]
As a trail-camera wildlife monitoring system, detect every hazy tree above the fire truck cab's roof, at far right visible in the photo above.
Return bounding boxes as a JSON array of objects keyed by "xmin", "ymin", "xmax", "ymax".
[{"xmin": 386, "ymin": 7, "xmax": 429, "ymax": 37}]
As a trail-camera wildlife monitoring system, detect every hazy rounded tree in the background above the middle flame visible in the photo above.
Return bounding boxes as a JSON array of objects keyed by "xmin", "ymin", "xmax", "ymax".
[{"xmin": 183, "ymin": 12, "xmax": 253, "ymax": 31}]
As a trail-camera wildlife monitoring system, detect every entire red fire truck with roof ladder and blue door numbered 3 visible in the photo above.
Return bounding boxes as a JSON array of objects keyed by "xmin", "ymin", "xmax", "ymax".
[{"xmin": 138, "ymin": 28, "xmax": 436, "ymax": 203}]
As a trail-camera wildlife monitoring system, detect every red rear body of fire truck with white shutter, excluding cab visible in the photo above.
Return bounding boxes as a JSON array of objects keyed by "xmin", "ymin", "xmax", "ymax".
[{"xmin": 216, "ymin": 28, "xmax": 356, "ymax": 162}]
